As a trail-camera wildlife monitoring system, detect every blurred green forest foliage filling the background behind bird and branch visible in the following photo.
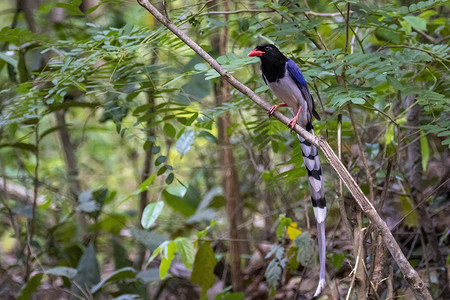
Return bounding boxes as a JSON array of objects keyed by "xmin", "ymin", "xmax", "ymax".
[{"xmin": 0, "ymin": 0, "xmax": 450, "ymax": 299}]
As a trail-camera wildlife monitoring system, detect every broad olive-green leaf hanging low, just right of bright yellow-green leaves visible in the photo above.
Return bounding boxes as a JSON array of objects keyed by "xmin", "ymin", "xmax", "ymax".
[{"xmin": 191, "ymin": 242, "xmax": 217, "ymax": 296}]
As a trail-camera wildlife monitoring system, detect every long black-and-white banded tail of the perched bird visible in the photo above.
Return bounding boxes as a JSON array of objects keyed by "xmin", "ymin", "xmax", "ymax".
[{"xmin": 298, "ymin": 125, "xmax": 327, "ymax": 297}]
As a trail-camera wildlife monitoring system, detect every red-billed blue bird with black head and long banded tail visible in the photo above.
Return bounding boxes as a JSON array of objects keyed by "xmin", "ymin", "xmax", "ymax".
[{"xmin": 248, "ymin": 44, "xmax": 327, "ymax": 297}]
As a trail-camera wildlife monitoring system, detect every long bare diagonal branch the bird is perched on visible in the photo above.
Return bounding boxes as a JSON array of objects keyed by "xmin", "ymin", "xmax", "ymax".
[{"xmin": 137, "ymin": 0, "xmax": 432, "ymax": 300}]
